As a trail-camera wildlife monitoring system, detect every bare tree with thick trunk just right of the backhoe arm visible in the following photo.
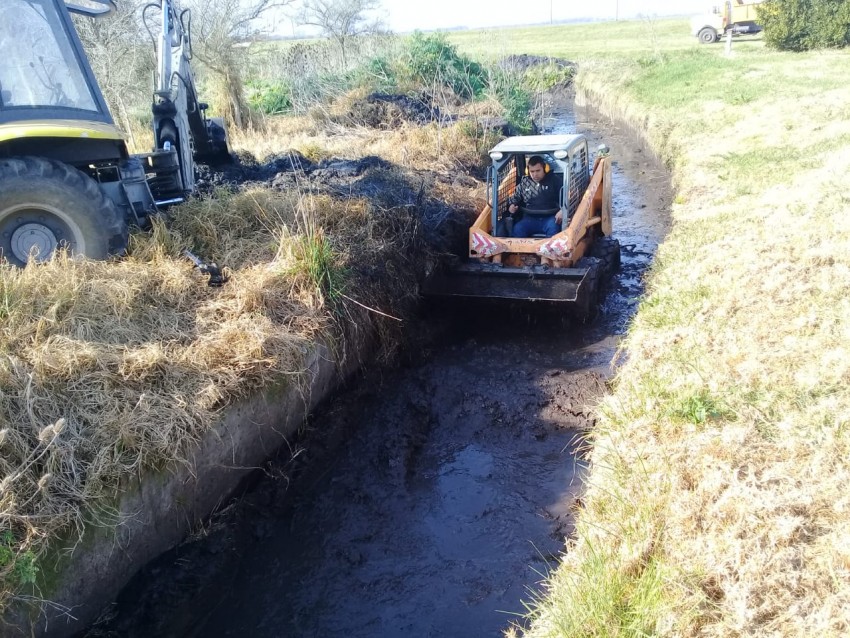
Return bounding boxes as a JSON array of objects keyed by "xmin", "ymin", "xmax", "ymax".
[{"xmin": 184, "ymin": 0, "xmax": 293, "ymax": 128}]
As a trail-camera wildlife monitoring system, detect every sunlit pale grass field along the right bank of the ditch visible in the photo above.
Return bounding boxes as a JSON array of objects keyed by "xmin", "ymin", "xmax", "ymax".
[{"xmin": 444, "ymin": 20, "xmax": 850, "ymax": 638}]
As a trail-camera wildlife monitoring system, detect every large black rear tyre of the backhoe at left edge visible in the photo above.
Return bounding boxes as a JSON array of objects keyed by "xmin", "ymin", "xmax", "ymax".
[{"xmin": 0, "ymin": 157, "xmax": 129, "ymax": 266}]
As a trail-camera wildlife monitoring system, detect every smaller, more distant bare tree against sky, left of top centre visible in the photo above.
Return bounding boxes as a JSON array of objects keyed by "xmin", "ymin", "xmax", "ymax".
[{"xmin": 296, "ymin": 0, "xmax": 382, "ymax": 66}]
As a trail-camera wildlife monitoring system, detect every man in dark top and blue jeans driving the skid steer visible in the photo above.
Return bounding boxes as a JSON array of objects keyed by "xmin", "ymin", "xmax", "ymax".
[{"xmin": 508, "ymin": 155, "xmax": 563, "ymax": 237}]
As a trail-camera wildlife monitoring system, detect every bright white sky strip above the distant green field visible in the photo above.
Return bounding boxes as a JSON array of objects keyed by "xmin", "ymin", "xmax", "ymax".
[{"xmin": 280, "ymin": 0, "xmax": 721, "ymax": 35}]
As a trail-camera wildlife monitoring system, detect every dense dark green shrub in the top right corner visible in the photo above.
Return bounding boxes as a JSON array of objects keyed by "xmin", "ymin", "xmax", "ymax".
[{"xmin": 758, "ymin": 0, "xmax": 850, "ymax": 51}]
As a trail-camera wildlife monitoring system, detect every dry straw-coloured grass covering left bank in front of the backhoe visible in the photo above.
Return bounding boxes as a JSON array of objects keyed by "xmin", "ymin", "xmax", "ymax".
[{"xmin": 0, "ymin": 161, "xmax": 438, "ymax": 607}]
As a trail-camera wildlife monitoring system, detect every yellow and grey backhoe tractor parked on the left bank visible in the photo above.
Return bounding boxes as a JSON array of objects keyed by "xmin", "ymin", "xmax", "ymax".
[{"xmin": 0, "ymin": 0, "xmax": 230, "ymax": 266}]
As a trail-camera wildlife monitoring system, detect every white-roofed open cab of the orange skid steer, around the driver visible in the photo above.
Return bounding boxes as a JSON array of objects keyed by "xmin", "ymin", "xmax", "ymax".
[{"xmin": 487, "ymin": 135, "xmax": 590, "ymax": 237}]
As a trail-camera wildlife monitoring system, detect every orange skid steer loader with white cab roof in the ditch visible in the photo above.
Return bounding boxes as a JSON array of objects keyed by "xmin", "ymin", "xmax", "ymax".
[{"xmin": 423, "ymin": 135, "xmax": 620, "ymax": 316}]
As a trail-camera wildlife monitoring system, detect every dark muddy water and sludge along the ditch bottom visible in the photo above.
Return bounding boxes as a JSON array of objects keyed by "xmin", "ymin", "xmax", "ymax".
[{"xmin": 87, "ymin": 95, "xmax": 670, "ymax": 638}]
